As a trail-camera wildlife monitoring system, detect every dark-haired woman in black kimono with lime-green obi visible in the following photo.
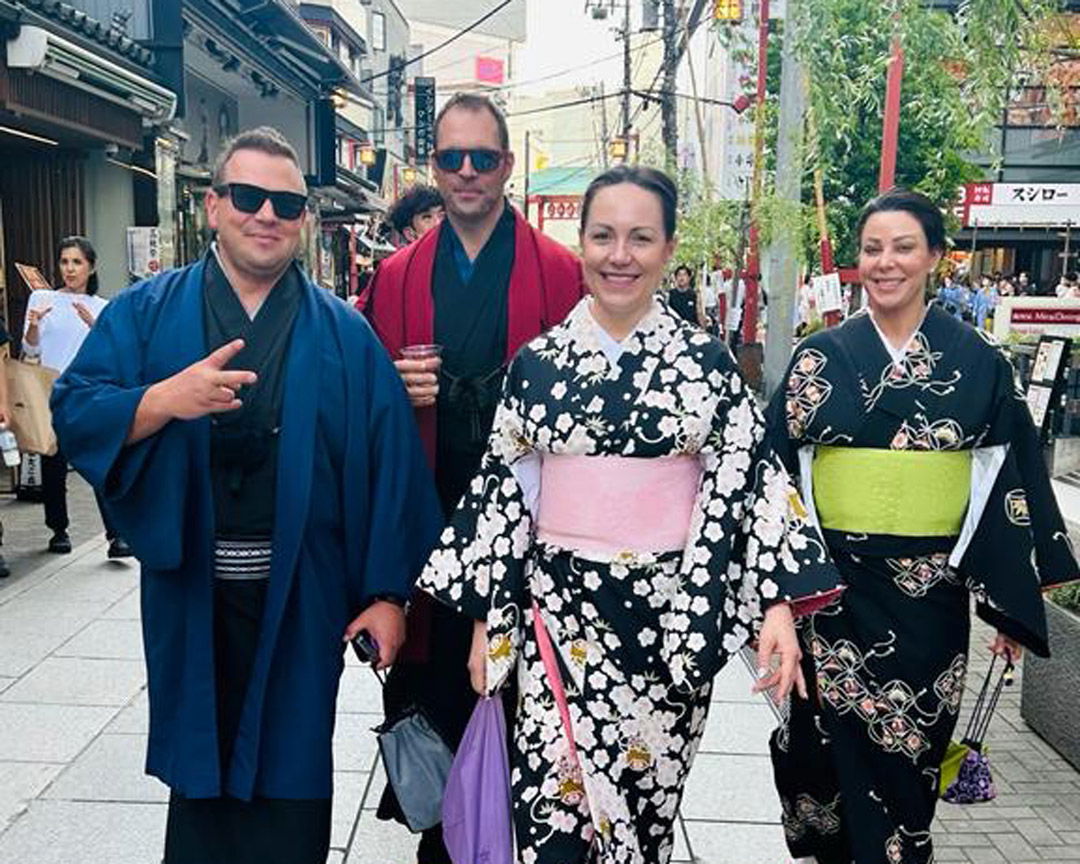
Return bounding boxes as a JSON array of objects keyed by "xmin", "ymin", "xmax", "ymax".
[{"xmin": 769, "ymin": 190, "xmax": 1078, "ymax": 864}]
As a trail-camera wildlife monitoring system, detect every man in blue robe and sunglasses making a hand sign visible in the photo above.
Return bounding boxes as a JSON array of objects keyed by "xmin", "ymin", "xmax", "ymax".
[{"xmin": 53, "ymin": 127, "xmax": 441, "ymax": 864}]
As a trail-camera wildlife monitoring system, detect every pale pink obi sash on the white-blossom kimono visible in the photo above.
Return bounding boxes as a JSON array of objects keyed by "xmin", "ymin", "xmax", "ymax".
[{"xmin": 537, "ymin": 454, "xmax": 701, "ymax": 561}]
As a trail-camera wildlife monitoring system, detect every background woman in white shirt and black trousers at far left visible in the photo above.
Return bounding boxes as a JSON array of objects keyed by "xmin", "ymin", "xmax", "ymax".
[{"xmin": 23, "ymin": 237, "xmax": 131, "ymax": 558}]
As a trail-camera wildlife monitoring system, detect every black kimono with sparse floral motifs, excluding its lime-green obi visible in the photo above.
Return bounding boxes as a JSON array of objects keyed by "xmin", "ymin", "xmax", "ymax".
[{"xmin": 769, "ymin": 306, "xmax": 1078, "ymax": 864}]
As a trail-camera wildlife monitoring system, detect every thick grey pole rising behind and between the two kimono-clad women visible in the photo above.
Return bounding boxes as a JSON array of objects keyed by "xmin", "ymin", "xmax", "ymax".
[{"xmin": 764, "ymin": 0, "xmax": 807, "ymax": 397}]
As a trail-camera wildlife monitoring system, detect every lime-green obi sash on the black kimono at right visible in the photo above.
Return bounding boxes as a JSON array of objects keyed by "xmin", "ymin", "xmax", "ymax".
[{"xmin": 812, "ymin": 446, "xmax": 971, "ymax": 537}]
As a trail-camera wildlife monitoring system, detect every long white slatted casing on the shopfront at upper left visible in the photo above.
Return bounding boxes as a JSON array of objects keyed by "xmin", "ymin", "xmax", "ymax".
[{"xmin": 8, "ymin": 25, "xmax": 176, "ymax": 123}]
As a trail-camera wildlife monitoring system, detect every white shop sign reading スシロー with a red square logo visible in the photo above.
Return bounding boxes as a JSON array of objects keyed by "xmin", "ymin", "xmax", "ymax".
[{"xmin": 963, "ymin": 183, "xmax": 1080, "ymax": 228}]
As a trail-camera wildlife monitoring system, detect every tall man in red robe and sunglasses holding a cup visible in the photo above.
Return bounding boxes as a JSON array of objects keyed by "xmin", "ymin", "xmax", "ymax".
[{"xmin": 366, "ymin": 94, "xmax": 585, "ymax": 864}]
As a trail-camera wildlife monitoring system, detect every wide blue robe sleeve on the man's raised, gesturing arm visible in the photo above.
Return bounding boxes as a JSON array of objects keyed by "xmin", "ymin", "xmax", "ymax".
[{"xmin": 51, "ymin": 295, "xmax": 189, "ymax": 570}]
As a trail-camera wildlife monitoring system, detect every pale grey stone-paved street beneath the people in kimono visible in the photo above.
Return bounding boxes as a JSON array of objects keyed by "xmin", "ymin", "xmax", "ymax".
[{"xmin": 0, "ymin": 477, "xmax": 1080, "ymax": 864}]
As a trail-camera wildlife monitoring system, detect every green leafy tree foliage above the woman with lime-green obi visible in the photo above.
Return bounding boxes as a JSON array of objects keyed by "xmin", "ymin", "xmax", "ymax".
[{"xmin": 793, "ymin": 0, "xmax": 1057, "ymax": 261}]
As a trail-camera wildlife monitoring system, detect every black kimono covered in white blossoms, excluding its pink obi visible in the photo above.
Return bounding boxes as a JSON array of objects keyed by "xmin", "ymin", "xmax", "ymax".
[{"xmin": 419, "ymin": 299, "xmax": 838, "ymax": 864}]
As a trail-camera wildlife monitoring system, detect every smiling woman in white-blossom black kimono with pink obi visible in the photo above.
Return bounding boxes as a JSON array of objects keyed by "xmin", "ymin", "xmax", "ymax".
[{"xmin": 419, "ymin": 167, "xmax": 838, "ymax": 864}]
